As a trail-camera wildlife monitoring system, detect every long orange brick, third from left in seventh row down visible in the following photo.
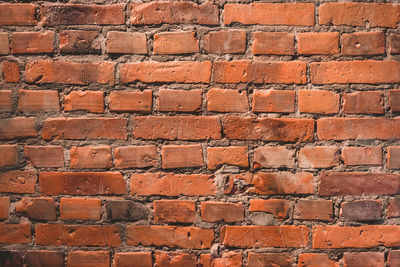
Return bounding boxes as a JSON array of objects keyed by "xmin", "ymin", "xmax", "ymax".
[{"xmin": 130, "ymin": 173, "xmax": 216, "ymax": 196}]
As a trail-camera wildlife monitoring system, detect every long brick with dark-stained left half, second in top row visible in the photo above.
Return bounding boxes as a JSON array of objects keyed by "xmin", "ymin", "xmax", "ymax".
[{"xmin": 42, "ymin": 4, "xmax": 125, "ymax": 26}]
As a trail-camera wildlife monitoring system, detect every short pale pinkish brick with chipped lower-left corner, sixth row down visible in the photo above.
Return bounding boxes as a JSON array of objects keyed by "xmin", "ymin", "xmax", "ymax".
[{"xmin": 253, "ymin": 146, "xmax": 294, "ymax": 169}]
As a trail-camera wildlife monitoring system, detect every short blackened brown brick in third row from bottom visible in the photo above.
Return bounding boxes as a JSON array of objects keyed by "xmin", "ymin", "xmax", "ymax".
[{"xmin": 106, "ymin": 199, "xmax": 150, "ymax": 221}]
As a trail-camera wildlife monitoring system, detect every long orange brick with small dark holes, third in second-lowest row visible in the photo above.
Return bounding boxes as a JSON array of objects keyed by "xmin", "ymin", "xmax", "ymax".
[{"xmin": 126, "ymin": 225, "xmax": 214, "ymax": 249}]
